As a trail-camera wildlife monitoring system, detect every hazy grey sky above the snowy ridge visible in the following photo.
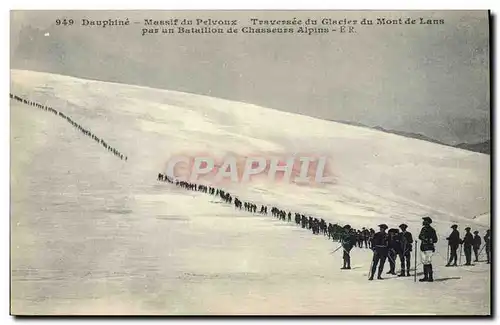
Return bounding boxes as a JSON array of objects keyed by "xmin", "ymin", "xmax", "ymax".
[{"xmin": 11, "ymin": 11, "xmax": 490, "ymax": 144}]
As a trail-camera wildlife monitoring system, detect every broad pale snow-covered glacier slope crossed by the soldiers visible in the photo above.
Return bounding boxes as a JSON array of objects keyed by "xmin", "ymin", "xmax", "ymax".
[{"xmin": 11, "ymin": 70, "xmax": 490, "ymax": 314}]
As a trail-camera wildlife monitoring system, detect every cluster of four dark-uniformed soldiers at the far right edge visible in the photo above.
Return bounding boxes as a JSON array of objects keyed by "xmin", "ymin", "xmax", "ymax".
[{"xmin": 446, "ymin": 225, "xmax": 491, "ymax": 267}]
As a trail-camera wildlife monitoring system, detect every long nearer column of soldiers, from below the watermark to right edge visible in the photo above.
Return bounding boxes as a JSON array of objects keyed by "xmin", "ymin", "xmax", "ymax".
[{"xmin": 157, "ymin": 173, "xmax": 491, "ymax": 282}]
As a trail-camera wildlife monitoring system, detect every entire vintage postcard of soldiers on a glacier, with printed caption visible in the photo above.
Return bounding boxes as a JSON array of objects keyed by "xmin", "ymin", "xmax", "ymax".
[{"xmin": 10, "ymin": 10, "xmax": 492, "ymax": 316}]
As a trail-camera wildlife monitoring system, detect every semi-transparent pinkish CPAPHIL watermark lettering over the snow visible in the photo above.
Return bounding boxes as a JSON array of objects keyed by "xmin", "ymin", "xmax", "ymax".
[{"xmin": 165, "ymin": 154, "xmax": 334, "ymax": 185}]
